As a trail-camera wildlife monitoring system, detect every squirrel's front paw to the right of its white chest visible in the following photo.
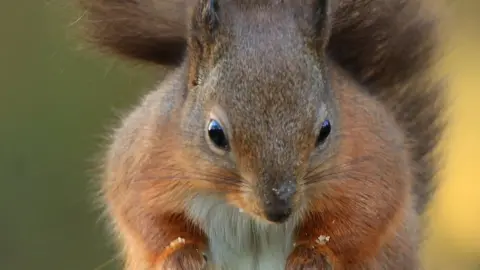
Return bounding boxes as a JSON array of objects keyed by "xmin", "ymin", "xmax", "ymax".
[{"xmin": 285, "ymin": 246, "xmax": 334, "ymax": 270}]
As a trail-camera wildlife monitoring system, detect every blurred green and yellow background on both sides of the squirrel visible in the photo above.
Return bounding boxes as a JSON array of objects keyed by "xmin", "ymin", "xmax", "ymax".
[{"xmin": 0, "ymin": 0, "xmax": 480, "ymax": 270}]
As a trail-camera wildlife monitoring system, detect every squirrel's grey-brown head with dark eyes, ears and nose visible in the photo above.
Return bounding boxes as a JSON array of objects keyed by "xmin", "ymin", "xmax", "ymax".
[{"xmin": 180, "ymin": 0, "xmax": 339, "ymax": 223}]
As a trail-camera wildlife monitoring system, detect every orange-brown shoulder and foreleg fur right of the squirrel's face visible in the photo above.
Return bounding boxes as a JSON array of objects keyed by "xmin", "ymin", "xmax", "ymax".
[{"xmin": 288, "ymin": 66, "xmax": 419, "ymax": 270}]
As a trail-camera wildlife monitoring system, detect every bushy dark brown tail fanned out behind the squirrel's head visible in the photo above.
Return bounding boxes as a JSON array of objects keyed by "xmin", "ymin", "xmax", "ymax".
[{"xmin": 79, "ymin": 0, "xmax": 444, "ymax": 212}]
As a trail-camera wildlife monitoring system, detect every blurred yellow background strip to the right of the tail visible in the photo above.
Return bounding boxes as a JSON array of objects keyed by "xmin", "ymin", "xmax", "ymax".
[{"xmin": 424, "ymin": 1, "xmax": 480, "ymax": 270}]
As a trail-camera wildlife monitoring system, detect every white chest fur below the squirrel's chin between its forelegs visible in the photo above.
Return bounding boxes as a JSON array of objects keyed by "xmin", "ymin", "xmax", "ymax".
[{"xmin": 189, "ymin": 196, "xmax": 294, "ymax": 270}]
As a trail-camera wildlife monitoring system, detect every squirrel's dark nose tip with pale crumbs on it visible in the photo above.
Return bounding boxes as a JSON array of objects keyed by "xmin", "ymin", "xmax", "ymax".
[{"xmin": 264, "ymin": 181, "xmax": 296, "ymax": 223}]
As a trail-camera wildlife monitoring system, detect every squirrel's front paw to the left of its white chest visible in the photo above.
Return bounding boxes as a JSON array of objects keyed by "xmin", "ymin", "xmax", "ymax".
[{"xmin": 155, "ymin": 238, "xmax": 207, "ymax": 270}]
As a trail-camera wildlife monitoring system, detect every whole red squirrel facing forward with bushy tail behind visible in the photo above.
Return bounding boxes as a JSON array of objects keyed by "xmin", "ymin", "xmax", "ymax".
[{"xmin": 82, "ymin": 0, "xmax": 445, "ymax": 270}]
